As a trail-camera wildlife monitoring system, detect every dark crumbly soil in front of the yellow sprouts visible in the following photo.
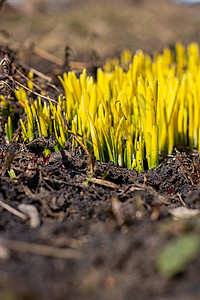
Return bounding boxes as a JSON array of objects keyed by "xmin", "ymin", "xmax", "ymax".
[{"xmin": 0, "ymin": 137, "xmax": 200, "ymax": 299}]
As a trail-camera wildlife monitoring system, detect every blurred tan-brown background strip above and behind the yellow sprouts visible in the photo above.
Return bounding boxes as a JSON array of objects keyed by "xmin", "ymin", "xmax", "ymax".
[{"xmin": 0, "ymin": 0, "xmax": 200, "ymax": 69}]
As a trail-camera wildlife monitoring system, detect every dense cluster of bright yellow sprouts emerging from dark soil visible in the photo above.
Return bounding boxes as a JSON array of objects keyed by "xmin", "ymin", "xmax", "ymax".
[{"xmin": 3, "ymin": 43, "xmax": 200, "ymax": 171}]
